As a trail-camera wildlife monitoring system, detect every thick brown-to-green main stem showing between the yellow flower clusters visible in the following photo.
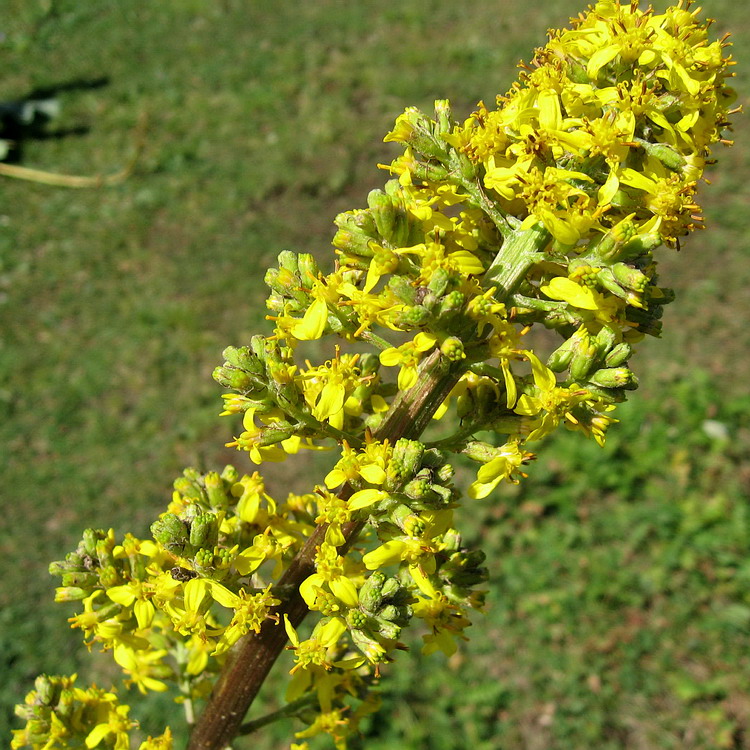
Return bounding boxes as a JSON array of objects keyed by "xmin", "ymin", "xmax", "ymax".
[{"xmin": 188, "ymin": 220, "xmax": 549, "ymax": 750}]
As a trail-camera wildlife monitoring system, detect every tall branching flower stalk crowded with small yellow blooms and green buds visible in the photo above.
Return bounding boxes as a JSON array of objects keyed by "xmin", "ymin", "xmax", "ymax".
[{"xmin": 13, "ymin": 1, "xmax": 734, "ymax": 750}]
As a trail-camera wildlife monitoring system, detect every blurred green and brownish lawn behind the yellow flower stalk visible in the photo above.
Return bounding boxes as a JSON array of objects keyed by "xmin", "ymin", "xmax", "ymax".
[{"xmin": 0, "ymin": 0, "xmax": 750, "ymax": 750}]
